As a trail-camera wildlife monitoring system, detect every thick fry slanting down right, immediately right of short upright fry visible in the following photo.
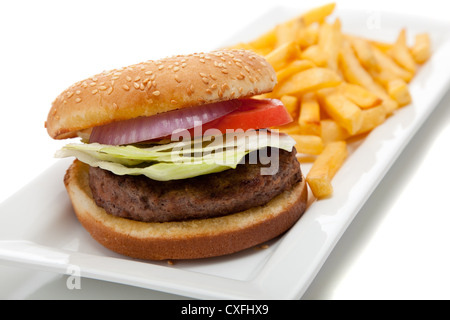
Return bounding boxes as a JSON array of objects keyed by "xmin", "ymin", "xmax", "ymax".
[{"xmin": 318, "ymin": 89, "xmax": 362, "ymax": 134}]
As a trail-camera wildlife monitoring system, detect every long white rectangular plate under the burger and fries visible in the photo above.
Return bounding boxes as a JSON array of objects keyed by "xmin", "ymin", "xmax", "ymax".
[{"xmin": 0, "ymin": 8, "xmax": 450, "ymax": 299}]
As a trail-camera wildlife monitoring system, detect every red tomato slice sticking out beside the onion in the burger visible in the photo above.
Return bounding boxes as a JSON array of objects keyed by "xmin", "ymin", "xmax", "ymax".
[{"xmin": 195, "ymin": 99, "xmax": 293, "ymax": 133}]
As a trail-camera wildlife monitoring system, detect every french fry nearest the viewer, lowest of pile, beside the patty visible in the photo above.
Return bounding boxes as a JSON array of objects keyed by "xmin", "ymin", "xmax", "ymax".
[{"xmin": 306, "ymin": 141, "xmax": 348, "ymax": 199}]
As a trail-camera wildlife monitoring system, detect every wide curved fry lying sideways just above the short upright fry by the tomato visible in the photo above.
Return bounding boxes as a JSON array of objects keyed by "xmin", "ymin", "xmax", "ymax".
[{"xmin": 274, "ymin": 68, "xmax": 342, "ymax": 96}]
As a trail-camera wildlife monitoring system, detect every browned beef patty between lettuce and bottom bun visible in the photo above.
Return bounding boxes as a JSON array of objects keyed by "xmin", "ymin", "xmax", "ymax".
[{"xmin": 89, "ymin": 149, "xmax": 302, "ymax": 222}]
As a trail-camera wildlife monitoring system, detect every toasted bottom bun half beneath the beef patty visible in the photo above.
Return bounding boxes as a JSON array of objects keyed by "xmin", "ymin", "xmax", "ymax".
[{"xmin": 64, "ymin": 160, "xmax": 307, "ymax": 260}]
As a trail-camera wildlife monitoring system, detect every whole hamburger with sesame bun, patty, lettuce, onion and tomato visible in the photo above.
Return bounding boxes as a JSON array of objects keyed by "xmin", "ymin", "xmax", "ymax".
[{"xmin": 45, "ymin": 50, "xmax": 307, "ymax": 260}]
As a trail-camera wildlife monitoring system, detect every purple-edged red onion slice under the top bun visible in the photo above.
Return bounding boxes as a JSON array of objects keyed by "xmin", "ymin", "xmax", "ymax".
[{"xmin": 89, "ymin": 99, "xmax": 241, "ymax": 145}]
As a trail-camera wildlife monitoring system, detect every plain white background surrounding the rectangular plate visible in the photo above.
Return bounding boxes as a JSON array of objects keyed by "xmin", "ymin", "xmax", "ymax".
[{"xmin": 0, "ymin": 0, "xmax": 450, "ymax": 299}]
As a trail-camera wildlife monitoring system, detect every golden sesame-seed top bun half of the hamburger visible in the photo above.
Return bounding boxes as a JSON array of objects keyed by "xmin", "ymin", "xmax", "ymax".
[{"xmin": 45, "ymin": 49, "xmax": 276, "ymax": 139}]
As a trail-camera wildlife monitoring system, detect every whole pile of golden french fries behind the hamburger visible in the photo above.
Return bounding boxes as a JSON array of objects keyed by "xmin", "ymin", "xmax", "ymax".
[{"xmin": 233, "ymin": 3, "xmax": 431, "ymax": 199}]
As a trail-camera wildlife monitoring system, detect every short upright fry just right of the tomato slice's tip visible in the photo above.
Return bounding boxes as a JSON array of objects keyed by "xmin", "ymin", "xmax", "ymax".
[{"xmin": 298, "ymin": 94, "xmax": 321, "ymax": 136}]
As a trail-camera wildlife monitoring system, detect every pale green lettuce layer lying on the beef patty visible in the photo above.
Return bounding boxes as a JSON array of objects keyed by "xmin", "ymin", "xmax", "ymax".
[{"xmin": 55, "ymin": 130, "xmax": 295, "ymax": 181}]
